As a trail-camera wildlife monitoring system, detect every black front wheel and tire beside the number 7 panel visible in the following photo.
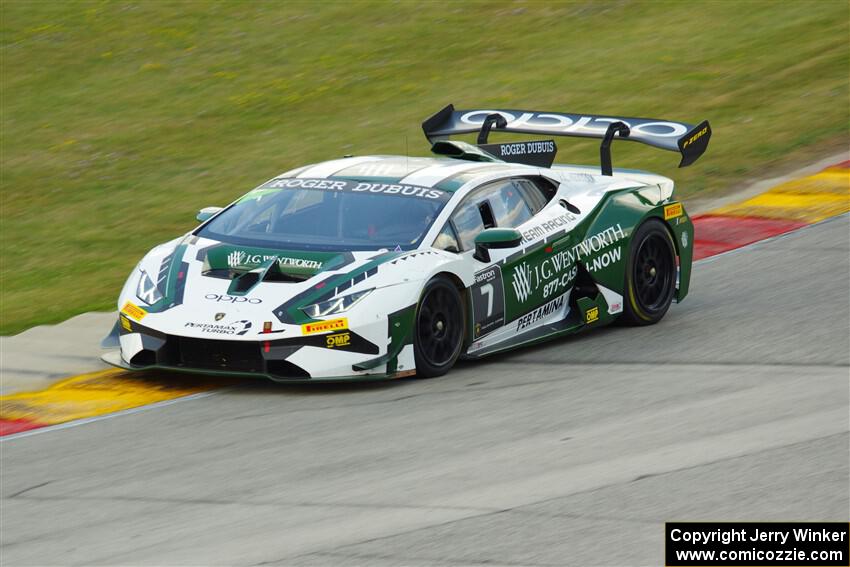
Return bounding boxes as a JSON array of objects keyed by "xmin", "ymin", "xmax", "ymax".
[{"xmin": 413, "ymin": 276, "xmax": 465, "ymax": 378}]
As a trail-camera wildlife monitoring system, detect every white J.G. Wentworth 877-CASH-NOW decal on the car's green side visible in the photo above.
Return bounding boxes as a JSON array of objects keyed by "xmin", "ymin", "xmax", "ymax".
[{"xmin": 511, "ymin": 224, "xmax": 626, "ymax": 303}]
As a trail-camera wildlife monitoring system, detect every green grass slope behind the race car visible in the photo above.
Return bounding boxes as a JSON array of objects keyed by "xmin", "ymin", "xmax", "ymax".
[{"xmin": 0, "ymin": 0, "xmax": 850, "ymax": 334}]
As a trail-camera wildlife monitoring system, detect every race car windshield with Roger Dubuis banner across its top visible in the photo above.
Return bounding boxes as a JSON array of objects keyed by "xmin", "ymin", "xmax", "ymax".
[{"xmin": 196, "ymin": 179, "xmax": 451, "ymax": 250}]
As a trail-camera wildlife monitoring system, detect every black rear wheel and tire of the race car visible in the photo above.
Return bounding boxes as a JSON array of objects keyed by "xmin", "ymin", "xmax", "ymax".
[{"xmin": 620, "ymin": 218, "xmax": 677, "ymax": 326}]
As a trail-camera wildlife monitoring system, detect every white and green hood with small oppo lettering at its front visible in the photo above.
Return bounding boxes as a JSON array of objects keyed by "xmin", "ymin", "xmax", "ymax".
[{"xmin": 124, "ymin": 235, "xmax": 435, "ymax": 338}]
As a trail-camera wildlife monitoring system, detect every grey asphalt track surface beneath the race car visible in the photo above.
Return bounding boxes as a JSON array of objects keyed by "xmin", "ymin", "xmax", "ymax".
[{"xmin": 0, "ymin": 215, "xmax": 850, "ymax": 566}]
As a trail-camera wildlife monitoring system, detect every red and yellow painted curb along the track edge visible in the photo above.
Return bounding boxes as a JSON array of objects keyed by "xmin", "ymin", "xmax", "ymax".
[{"xmin": 0, "ymin": 161, "xmax": 850, "ymax": 441}]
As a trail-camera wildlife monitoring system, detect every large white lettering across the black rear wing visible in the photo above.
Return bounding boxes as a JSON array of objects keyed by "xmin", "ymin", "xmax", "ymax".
[{"xmin": 460, "ymin": 110, "xmax": 688, "ymax": 138}]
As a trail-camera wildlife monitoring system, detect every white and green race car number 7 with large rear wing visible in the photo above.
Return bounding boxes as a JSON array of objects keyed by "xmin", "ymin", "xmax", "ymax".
[{"xmin": 104, "ymin": 105, "xmax": 711, "ymax": 381}]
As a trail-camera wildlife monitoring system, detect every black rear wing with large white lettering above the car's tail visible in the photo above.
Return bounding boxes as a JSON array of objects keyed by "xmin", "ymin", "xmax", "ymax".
[{"xmin": 422, "ymin": 104, "xmax": 711, "ymax": 175}]
